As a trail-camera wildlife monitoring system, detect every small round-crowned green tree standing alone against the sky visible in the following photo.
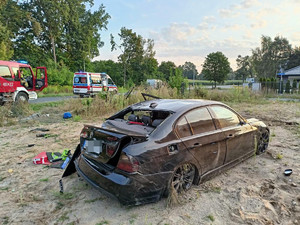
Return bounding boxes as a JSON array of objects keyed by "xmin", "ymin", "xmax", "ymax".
[{"xmin": 202, "ymin": 52, "xmax": 230, "ymax": 88}]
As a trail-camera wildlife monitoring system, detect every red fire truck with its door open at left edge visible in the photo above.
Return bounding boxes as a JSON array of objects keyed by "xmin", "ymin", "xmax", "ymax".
[{"xmin": 0, "ymin": 60, "xmax": 48, "ymax": 105}]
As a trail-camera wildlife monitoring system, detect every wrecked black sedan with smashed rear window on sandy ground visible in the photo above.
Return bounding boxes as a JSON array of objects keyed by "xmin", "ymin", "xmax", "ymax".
[{"xmin": 63, "ymin": 99, "xmax": 269, "ymax": 205}]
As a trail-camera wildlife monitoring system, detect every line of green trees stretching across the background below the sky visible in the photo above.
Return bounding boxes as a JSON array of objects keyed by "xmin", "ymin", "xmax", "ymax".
[{"xmin": 0, "ymin": 0, "xmax": 300, "ymax": 88}]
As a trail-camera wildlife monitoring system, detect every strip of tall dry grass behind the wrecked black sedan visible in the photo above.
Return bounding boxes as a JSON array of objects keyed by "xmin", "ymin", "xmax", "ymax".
[{"xmin": 0, "ymin": 86, "xmax": 263, "ymax": 126}]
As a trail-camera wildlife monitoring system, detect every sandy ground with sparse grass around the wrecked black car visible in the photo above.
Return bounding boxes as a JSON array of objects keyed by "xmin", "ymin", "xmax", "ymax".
[{"xmin": 0, "ymin": 102, "xmax": 300, "ymax": 225}]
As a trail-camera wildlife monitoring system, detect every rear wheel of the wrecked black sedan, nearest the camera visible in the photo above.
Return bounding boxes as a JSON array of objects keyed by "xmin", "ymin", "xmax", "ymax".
[{"xmin": 171, "ymin": 163, "xmax": 196, "ymax": 194}]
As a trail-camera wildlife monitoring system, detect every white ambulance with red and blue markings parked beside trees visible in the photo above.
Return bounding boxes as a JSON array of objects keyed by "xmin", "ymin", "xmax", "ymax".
[{"xmin": 73, "ymin": 72, "xmax": 118, "ymax": 98}]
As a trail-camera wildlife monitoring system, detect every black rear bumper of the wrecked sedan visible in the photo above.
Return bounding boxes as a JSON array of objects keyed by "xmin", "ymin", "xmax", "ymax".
[{"xmin": 74, "ymin": 156, "xmax": 172, "ymax": 205}]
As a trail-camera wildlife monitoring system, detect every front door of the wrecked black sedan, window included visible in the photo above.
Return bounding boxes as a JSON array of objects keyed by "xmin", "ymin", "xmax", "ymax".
[{"xmin": 210, "ymin": 105, "xmax": 255, "ymax": 164}]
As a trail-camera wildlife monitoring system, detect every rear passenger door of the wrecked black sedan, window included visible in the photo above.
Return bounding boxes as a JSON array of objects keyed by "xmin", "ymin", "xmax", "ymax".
[{"xmin": 175, "ymin": 107, "xmax": 226, "ymax": 174}]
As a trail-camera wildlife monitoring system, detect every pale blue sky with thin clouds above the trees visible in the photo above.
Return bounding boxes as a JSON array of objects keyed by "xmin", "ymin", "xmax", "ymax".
[{"xmin": 93, "ymin": 0, "xmax": 300, "ymax": 72}]
